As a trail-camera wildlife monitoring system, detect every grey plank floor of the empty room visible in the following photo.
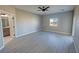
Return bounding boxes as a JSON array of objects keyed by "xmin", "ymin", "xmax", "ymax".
[{"xmin": 0, "ymin": 31, "xmax": 75, "ymax": 53}]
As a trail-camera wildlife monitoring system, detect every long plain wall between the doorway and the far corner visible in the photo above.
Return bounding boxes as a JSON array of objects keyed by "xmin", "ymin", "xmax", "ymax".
[{"xmin": 16, "ymin": 9, "xmax": 41, "ymax": 37}]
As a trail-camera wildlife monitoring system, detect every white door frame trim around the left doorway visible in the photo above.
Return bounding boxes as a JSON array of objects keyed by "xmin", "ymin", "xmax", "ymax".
[{"xmin": 0, "ymin": 10, "xmax": 16, "ymax": 49}]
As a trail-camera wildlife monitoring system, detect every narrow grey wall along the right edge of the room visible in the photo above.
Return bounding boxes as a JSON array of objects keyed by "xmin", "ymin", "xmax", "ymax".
[{"xmin": 73, "ymin": 6, "xmax": 79, "ymax": 52}]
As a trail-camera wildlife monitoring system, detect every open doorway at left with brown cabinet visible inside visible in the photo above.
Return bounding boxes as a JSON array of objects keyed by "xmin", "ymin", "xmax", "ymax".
[{"xmin": 0, "ymin": 13, "xmax": 14, "ymax": 44}]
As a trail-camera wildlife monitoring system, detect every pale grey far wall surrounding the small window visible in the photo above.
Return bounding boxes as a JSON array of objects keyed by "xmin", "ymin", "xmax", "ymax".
[{"xmin": 43, "ymin": 11, "xmax": 73, "ymax": 34}]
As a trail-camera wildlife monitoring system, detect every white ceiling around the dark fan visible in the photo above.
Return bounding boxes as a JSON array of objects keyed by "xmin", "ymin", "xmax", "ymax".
[{"xmin": 15, "ymin": 5, "xmax": 74, "ymax": 15}]
